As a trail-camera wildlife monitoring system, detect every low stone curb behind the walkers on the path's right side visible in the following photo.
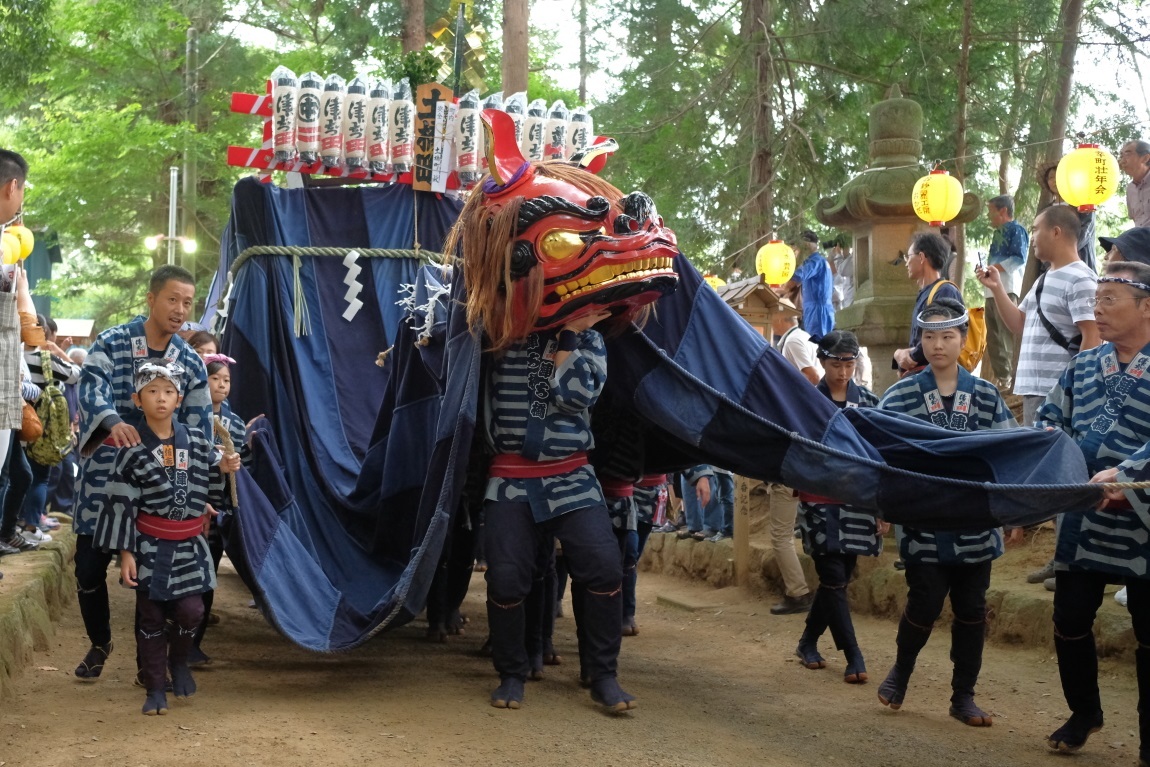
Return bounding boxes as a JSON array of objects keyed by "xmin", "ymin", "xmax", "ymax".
[{"xmin": 639, "ymin": 534, "xmax": 1137, "ymax": 662}]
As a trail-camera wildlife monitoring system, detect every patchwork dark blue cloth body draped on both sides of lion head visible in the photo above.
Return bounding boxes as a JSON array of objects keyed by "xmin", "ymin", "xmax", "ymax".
[{"xmin": 216, "ymin": 181, "xmax": 1099, "ymax": 652}]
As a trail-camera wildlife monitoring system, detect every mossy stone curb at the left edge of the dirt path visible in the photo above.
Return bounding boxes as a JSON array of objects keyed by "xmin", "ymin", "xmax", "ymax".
[{"xmin": 0, "ymin": 527, "xmax": 76, "ymax": 700}]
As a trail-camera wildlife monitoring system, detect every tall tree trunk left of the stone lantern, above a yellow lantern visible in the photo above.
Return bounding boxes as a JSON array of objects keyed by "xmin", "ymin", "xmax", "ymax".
[{"xmin": 741, "ymin": 0, "xmax": 775, "ymax": 270}]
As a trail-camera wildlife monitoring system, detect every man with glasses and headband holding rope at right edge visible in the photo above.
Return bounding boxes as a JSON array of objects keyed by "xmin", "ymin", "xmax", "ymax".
[{"xmin": 1035, "ymin": 261, "xmax": 1150, "ymax": 766}]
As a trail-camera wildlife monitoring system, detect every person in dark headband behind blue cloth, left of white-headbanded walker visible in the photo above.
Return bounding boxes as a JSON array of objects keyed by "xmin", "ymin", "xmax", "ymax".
[{"xmin": 795, "ymin": 330, "xmax": 890, "ymax": 684}]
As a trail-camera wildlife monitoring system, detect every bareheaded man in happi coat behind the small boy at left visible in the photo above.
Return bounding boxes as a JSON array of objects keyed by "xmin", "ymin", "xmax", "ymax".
[{"xmin": 72, "ymin": 266, "xmax": 212, "ymax": 680}]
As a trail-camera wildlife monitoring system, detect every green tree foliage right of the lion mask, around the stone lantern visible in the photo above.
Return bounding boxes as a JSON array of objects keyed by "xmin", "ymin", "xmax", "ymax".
[{"xmin": 596, "ymin": 0, "xmax": 1150, "ymax": 269}]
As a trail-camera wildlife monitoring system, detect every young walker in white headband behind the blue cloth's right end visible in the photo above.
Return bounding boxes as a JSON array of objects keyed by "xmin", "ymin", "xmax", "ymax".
[{"xmin": 879, "ymin": 298, "xmax": 1015, "ymax": 727}]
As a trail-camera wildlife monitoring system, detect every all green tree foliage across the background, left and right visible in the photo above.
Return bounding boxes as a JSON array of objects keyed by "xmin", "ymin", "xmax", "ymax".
[{"xmin": 0, "ymin": 0, "xmax": 1150, "ymax": 325}]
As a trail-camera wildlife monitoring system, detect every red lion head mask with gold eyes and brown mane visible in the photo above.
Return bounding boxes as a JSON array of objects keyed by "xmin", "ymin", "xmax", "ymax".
[{"xmin": 445, "ymin": 109, "xmax": 679, "ymax": 350}]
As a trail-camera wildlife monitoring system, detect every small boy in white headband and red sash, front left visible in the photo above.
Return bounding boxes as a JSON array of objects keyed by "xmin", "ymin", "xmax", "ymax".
[{"xmin": 92, "ymin": 362, "xmax": 239, "ymax": 715}]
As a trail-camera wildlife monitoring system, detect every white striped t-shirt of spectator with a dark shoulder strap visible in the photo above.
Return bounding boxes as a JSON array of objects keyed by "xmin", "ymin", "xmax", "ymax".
[{"xmin": 1014, "ymin": 261, "xmax": 1098, "ymax": 397}]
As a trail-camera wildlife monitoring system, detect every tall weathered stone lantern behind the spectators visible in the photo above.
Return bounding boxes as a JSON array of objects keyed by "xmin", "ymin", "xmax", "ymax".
[{"xmin": 815, "ymin": 85, "xmax": 982, "ymax": 394}]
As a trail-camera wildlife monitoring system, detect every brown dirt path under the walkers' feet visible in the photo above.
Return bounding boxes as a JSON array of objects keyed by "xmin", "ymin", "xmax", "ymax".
[{"xmin": 0, "ymin": 562, "xmax": 1137, "ymax": 767}]
